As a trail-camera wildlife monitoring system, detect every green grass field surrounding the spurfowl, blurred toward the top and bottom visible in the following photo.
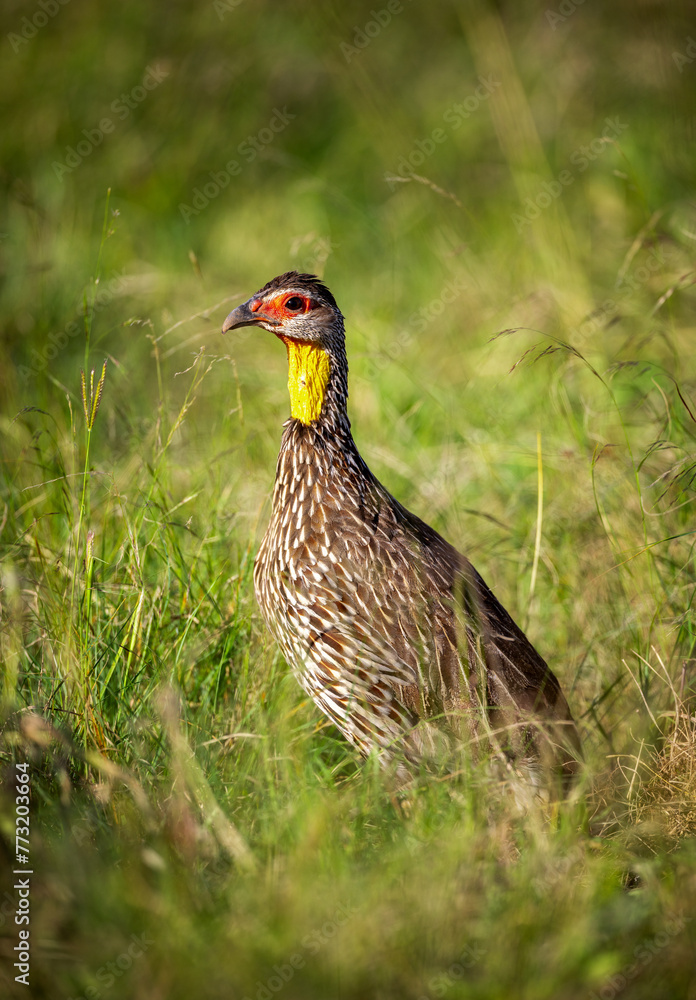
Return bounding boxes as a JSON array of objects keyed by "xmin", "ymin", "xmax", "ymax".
[{"xmin": 0, "ymin": 0, "xmax": 696, "ymax": 1000}]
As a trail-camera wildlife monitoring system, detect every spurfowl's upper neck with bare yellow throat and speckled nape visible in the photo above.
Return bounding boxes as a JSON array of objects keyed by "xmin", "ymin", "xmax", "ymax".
[{"xmin": 283, "ymin": 337, "xmax": 348, "ymax": 425}]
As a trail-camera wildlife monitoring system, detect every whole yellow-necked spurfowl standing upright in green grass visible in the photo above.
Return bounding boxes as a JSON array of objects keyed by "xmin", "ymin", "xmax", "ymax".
[{"xmin": 223, "ymin": 271, "xmax": 581, "ymax": 783}]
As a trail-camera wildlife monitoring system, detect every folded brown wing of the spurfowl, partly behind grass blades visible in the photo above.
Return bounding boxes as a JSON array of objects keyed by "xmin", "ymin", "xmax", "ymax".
[{"xmin": 332, "ymin": 481, "xmax": 581, "ymax": 776}]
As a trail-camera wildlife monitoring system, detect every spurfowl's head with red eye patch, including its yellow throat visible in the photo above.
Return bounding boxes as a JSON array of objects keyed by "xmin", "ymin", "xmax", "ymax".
[{"xmin": 222, "ymin": 271, "xmax": 347, "ymax": 424}]
